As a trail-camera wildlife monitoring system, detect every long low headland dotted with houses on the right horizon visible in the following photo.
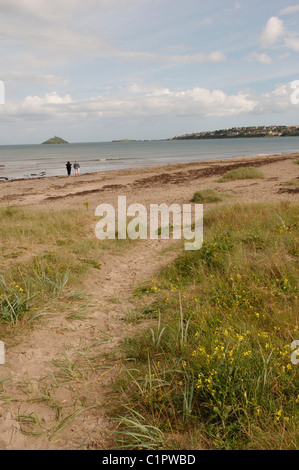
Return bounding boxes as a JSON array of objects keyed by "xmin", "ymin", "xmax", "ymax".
[{"xmin": 168, "ymin": 126, "xmax": 299, "ymax": 140}]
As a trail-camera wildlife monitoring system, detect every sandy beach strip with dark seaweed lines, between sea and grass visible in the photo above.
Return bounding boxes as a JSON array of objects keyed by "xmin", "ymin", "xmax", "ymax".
[{"xmin": 0, "ymin": 153, "xmax": 299, "ymax": 210}]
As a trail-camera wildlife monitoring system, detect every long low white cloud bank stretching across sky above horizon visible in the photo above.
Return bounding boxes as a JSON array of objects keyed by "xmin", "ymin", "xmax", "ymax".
[{"xmin": 0, "ymin": 83, "xmax": 294, "ymax": 125}]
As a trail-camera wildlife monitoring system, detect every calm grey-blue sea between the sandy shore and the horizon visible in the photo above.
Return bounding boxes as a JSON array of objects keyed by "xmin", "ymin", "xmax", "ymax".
[{"xmin": 0, "ymin": 137, "xmax": 299, "ymax": 181}]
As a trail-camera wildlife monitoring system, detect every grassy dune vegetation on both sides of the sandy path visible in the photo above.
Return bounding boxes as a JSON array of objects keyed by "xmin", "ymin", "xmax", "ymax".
[{"xmin": 0, "ymin": 202, "xmax": 299, "ymax": 450}]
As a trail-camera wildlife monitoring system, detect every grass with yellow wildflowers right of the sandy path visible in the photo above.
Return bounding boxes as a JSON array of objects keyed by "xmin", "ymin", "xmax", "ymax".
[{"xmin": 113, "ymin": 203, "xmax": 299, "ymax": 450}]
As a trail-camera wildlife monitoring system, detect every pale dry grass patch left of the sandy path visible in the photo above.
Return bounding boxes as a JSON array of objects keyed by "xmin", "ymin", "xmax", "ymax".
[{"xmin": 0, "ymin": 207, "xmax": 131, "ymax": 335}]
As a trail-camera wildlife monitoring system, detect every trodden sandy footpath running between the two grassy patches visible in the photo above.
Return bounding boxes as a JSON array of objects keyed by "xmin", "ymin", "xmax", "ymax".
[{"xmin": 0, "ymin": 240, "xmax": 178, "ymax": 450}]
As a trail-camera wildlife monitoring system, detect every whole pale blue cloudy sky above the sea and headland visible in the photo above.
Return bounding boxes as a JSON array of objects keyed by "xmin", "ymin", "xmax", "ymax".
[{"xmin": 0, "ymin": 0, "xmax": 299, "ymax": 145}]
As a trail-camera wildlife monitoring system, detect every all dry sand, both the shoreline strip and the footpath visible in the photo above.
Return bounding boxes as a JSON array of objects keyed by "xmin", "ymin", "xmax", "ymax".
[{"xmin": 0, "ymin": 153, "xmax": 299, "ymax": 450}]
